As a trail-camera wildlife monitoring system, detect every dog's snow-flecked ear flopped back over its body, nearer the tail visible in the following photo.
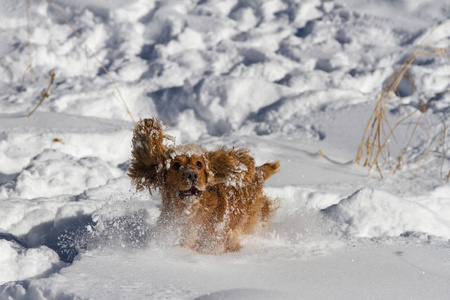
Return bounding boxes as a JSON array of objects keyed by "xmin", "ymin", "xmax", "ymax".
[{"xmin": 207, "ymin": 147, "xmax": 255, "ymax": 186}]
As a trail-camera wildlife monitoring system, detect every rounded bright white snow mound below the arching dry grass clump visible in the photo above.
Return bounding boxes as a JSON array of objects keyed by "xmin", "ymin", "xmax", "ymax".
[{"xmin": 323, "ymin": 188, "xmax": 450, "ymax": 239}]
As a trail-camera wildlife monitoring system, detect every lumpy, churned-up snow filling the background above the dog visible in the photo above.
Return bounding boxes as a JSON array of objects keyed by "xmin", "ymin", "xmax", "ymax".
[{"xmin": 6, "ymin": 0, "xmax": 445, "ymax": 140}]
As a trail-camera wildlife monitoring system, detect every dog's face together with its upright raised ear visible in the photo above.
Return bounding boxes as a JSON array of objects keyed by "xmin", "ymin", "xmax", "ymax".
[{"xmin": 128, "ymin": 119, "xmax": 213, "ymax": 199}]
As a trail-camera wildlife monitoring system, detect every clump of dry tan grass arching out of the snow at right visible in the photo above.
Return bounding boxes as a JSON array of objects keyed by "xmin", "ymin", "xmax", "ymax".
[{"xmin": 355, "ymin": 25, "xmax": 450, "ymax": 182}]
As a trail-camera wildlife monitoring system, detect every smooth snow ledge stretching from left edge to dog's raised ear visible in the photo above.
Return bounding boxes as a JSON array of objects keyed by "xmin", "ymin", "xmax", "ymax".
[{"xmin": 0, "ymin": 112, "xmax": 133, "ymax": 175}]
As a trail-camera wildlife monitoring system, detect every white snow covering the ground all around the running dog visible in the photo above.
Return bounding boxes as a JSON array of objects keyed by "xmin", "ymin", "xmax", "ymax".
[{"xmin": 0, "ymin": 0, "xmax": 450, "ymax": 299}]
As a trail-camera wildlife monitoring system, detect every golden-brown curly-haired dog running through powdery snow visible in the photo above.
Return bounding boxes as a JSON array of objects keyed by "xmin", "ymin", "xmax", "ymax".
[{"xmin": 128, "ymin": 118, "xmax": 280, "ymax": 254}]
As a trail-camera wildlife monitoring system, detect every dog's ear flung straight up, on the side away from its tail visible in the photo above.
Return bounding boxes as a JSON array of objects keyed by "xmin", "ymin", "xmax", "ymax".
[{"xmin": 128, "ymin": 118, "xmax": 170, "ymax": 193}]
